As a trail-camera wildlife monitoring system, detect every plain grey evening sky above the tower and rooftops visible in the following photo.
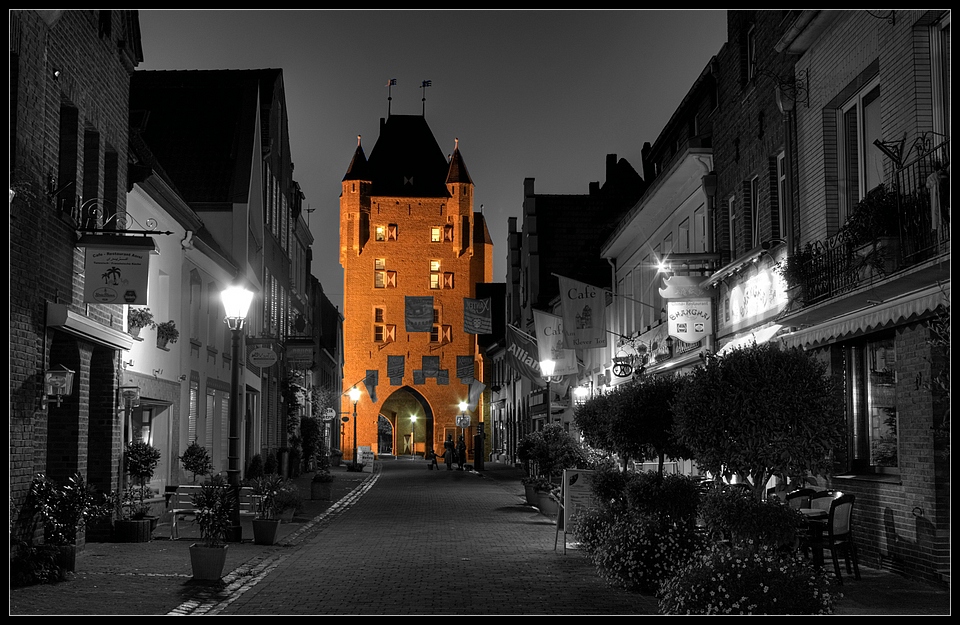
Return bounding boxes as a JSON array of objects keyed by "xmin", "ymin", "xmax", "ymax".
[{"xmin": 137, "ymin": 9, "xmax": 727, "ymax": 311}]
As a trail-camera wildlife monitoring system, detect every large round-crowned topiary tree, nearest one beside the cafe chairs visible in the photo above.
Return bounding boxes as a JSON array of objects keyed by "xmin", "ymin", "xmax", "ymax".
[{"xmin": 672, "ymin": 343, "xmax": 844, "ymax": 499}]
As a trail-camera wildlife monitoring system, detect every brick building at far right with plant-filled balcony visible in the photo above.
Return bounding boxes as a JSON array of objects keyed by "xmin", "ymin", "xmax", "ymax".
[{"xmin": 771, "ymin": 10, "xmax": 951, "ymax": 579}]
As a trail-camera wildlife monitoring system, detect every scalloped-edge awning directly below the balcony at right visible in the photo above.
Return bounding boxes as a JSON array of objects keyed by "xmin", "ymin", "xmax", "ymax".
[{"xmin": 780, "ymin": 283, "xmax": 950, "ymax": 348}]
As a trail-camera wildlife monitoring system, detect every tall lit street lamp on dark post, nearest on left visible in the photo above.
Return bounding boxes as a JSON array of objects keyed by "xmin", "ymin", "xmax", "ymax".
[{"xmin": 220, "ymin": 286, "xmax": 253, "ymax": 542}]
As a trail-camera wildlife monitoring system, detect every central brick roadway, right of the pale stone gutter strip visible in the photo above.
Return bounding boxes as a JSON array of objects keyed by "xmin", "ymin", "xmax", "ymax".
[{"xmin": 211, "ymin": 459, "xmax": 656, "ymax": 615}]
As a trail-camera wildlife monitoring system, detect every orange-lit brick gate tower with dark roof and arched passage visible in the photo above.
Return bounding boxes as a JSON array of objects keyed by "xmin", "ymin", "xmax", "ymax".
[{"xmin": 340, "ymin": 115, "xmax": 493, "ymax": 459}]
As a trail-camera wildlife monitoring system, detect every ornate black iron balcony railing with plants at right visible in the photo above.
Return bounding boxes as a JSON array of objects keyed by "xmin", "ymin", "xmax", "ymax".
[{"xmin": 787, "ymin": 140, "xmax": 950, "ymax": 306}]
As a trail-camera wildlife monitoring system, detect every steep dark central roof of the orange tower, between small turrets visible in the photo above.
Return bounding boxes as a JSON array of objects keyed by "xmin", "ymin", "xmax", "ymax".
[{"xmin": 367, "ymin": 115, "xmax": 450, "ymax": 197}]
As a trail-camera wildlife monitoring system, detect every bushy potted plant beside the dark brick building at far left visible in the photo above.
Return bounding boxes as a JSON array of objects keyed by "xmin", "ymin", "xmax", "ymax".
[{"xmin": 27, "ymin": 473, "xmax": 109, "ymax": 574}]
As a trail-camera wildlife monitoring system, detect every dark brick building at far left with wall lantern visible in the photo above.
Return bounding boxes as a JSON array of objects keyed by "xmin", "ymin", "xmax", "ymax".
[{"xmin": 9, "ymin": 10, "xmax": 144, "ymax": 538}]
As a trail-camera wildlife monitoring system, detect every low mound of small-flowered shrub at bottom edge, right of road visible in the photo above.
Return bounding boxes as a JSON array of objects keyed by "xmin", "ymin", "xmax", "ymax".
[{"xmin": 659, "ymin": 545, "xmax": 838, "ymax": 615}]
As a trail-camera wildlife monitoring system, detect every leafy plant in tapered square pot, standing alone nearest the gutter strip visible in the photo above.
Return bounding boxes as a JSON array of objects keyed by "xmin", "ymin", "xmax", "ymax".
[{"xmin": 190, "ymin": 475, "xmax": 235, "ymax": 581}]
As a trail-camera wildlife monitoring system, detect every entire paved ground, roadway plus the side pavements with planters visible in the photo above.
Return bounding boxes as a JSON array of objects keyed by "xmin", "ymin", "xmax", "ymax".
[{"xmin": 10, "ymin": 458, "xmax": 951, "ymax": 615}]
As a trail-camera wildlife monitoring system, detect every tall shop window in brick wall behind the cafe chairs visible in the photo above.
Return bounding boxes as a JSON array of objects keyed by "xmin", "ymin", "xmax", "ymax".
[{"xmin": 844, "ymin": 335, "xmax": 899, "ymax": 473}]
